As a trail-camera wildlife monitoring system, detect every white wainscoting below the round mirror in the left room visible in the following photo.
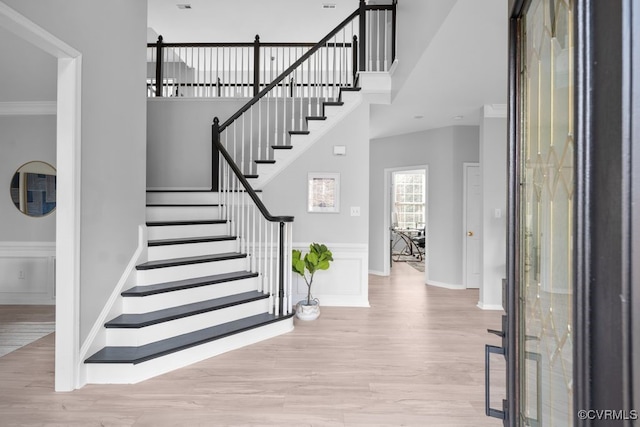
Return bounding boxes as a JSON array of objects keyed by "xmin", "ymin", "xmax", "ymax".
[{"xmin": 0, "ymin": 242, "xmax": 56, "ymax": 304}]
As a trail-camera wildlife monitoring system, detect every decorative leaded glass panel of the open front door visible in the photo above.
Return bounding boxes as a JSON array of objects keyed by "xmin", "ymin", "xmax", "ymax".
[{"xmin": 519, "ymin": 0, "xmax": 574, "ymax": 426}]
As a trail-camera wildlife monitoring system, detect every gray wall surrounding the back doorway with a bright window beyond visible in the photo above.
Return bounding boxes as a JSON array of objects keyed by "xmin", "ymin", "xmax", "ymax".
[{"xmin": 369, "ymin": 126, "xmax": 479, "ymax": 286}]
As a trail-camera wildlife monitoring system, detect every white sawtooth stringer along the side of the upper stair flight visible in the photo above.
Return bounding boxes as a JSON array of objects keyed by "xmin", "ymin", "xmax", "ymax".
[{"xmin": 250, "ymin": 91, "xmax": 364, "ymax": 189}]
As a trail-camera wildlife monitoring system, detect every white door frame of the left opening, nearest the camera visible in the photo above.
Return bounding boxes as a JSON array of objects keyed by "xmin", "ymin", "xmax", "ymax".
[{"xmin": 0, "ymin": 1, "xmax": 82, "ymax": 391}]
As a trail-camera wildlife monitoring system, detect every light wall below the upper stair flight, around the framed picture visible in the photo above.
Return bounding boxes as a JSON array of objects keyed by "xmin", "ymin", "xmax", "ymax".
[{"xmin": 262, "ymin": 103, "xmax": 370, "ymax": 306}]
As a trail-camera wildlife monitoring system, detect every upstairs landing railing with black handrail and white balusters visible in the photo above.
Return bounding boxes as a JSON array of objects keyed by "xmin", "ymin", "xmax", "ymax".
[{"xmin": 147, "ymin": 0, "xmax": 396, "ymax": 98}]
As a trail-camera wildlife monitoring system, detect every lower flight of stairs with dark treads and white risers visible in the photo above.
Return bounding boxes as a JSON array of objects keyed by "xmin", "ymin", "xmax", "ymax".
[{"xmin": 85, "ymin": 192, "xmax": 293, "ymax": 383}]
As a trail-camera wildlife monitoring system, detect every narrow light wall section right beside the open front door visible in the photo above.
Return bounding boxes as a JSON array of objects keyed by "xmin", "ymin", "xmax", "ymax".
[{"xmin": 478, "ymin": 106, "xmax": 507, "ymax": 309}]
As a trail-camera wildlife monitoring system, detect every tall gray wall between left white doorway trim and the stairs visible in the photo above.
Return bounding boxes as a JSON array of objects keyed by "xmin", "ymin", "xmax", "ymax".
[{"xmin": 6, "ymin": 0, "xmax": 147, "ymax": 343}]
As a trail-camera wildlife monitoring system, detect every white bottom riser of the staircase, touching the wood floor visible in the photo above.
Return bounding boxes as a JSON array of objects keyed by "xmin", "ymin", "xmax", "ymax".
[{"xmin": 86, "ymin": 317, "xmax": 293, "ymax": 384}]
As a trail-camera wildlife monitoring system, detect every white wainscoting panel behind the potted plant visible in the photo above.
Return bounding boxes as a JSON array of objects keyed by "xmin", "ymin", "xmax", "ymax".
[{"xmin": 292, "ymin": 242, "xmax": 369, "ymax": 307}]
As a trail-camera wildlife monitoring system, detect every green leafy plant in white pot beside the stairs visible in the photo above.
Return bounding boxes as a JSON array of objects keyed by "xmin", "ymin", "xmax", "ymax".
[{"xmin": 291, "ymin": 243, "xmax": 333, "ymax": 320}]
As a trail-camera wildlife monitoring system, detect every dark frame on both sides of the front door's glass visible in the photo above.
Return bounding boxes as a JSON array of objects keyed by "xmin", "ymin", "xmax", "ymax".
[{"xmin": 504, "ymin": 0, "xmax": 640, "ymax": 426}]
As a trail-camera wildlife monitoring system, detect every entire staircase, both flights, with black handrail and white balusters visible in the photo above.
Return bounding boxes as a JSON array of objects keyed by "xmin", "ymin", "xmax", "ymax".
[{"xmin": 83, "ymin": 1, "xmax": 395, "ymax": 383}]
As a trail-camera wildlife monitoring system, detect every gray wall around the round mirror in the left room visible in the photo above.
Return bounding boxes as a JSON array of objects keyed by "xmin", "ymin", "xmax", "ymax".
[{"xmin": 0, "ymin": 116, "xmax": 56, "ymax": 242}]
